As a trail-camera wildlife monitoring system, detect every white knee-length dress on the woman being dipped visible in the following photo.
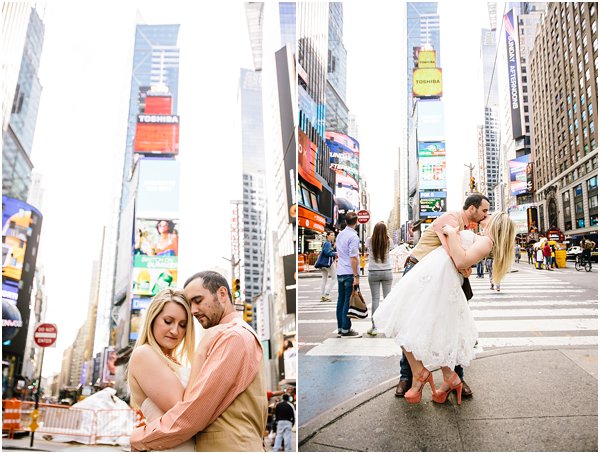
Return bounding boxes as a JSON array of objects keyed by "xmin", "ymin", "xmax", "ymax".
[{"xmin": 373, "ymin": 230, "xmax": 478, "ymax": 370}]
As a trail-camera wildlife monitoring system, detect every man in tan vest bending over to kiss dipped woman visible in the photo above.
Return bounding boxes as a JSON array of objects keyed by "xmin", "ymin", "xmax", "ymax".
[{"xmin": 390, "ymin": 194, "xmax": 492, "ymax": 397}]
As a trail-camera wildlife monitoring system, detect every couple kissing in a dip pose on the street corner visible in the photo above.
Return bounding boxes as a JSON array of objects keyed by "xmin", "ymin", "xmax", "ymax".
[{"xmin": 373, "ymin": 194, "xmax": 515, "ymax": 404}]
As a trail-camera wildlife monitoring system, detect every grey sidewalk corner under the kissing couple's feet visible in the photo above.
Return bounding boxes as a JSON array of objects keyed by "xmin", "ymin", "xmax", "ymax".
[{"xmin": 298, "ymin": 347, "xmax": 598, "ymax": 452}]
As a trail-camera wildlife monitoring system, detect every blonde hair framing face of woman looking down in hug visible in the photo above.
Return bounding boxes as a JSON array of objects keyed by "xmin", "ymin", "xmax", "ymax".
[{"xmin": 133, "ymin": 288, "xmax": 195, "ymax": 369}]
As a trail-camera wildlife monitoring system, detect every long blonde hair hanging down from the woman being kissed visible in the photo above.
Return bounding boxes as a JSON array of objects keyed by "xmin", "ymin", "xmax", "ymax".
[{"xmin": 485, "ymin": 211, "xmax": 516, "ymax": 284}]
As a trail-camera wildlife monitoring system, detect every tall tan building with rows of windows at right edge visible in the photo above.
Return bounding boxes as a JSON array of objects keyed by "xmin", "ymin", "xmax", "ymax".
[{"xmin": 530, "ymin": 2, "xmax": 598, "ymax": 244}]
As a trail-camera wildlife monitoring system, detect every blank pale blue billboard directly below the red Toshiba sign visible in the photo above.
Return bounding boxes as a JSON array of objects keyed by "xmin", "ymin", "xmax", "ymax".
[{"xmin": 135, "ymin": 158, "xmax": 179, "ymax": 219}]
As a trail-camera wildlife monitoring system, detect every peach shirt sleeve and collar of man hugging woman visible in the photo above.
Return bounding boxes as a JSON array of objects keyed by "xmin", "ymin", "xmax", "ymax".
[{"xmin": 130, "ymin": 312, "xmax": 263, "ymax": 451}]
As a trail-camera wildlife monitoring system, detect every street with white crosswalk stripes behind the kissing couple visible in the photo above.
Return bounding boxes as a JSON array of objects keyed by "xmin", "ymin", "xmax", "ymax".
[{"xmin": 298, "ymin": 261, "xmax": 598, "ymax": 428}]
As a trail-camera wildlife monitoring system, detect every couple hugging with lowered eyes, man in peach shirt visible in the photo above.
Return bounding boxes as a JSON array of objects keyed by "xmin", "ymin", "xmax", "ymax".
[{"xmin": 127, "ymin": 271, "xmax": 268, "ymax": 452}]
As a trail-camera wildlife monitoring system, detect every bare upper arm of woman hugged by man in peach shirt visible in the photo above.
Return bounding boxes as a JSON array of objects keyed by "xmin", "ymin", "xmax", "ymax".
[{"xmin": 129, "ymin": 345, "xmax": 184, "ymax": 412}]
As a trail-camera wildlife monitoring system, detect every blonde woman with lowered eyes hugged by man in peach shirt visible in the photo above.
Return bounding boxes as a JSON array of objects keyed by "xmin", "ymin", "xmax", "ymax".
[{"xmin": 127, "ymin": 288, "xmax": 195, "ymax": 452}]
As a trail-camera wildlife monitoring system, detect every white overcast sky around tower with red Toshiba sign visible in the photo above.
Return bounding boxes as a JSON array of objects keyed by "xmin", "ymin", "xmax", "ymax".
[{"xmin": 32, "ymin": 1, "xmax": 250, "ymax": 375}]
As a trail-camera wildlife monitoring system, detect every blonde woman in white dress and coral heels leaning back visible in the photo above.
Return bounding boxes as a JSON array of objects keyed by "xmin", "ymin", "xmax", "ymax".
[{"xmin": 373, "ymin": 212, "xmax": 515, "ymax": 404}]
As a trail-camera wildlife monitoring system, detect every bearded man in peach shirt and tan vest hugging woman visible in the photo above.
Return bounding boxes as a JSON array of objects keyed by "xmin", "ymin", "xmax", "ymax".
[{"xmin": 130, "ymin": 271, "xmax": 268, "ymax": 452}]
